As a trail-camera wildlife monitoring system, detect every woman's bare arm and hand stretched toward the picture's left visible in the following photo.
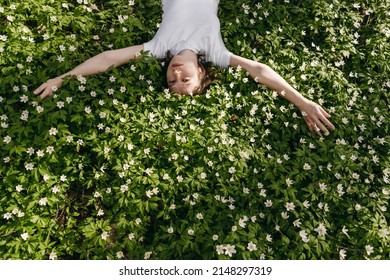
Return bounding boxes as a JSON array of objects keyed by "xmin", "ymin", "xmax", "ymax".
[{"xmin": 34, "ymin": 45, "xmax": 144, "ymax": 99}]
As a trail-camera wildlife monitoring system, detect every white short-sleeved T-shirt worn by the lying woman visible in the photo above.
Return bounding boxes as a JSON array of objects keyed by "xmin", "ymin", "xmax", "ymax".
[{"xmin": 144, "ymin": 0, "xmax": 232, "ymax": 68}]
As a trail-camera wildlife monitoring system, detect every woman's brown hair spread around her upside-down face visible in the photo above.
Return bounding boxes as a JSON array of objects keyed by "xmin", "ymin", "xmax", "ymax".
[{"xmin": 163, "ymin": 51, "xmax": 217, "ymax": 95}]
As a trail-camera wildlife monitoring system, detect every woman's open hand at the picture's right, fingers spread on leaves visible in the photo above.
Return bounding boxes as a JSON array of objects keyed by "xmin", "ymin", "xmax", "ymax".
[{"xmin": 298, "ymin": 99, "xmax": 335, "ymax": 137}]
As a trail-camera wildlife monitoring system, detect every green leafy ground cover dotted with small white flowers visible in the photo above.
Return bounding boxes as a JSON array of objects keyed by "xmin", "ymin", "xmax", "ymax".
[{"xmin": 0, "ymin": 0, "xmax": 390, "ymax": 259}]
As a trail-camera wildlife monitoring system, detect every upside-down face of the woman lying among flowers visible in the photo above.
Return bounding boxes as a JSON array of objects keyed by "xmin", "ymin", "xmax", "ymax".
[{"xmin": 167, "ymin": 56, "xmax": 202, "ymax": 95}]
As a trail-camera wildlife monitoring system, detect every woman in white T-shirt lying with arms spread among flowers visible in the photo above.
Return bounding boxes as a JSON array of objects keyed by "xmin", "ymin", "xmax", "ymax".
[{"xmin": 34, "ymin": 0, "xmax": 335, "ymax": 137}]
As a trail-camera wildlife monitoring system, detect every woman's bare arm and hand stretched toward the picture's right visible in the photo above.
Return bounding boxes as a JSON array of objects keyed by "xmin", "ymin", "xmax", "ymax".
[{"xmin": 230, "ymin": 55, "xmax": 335, "ymax": 136}]
